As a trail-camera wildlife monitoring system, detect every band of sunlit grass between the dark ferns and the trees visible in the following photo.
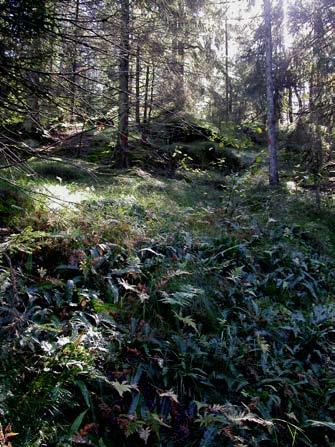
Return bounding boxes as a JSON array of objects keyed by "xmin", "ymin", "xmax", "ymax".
[{"xmin": 17, "ymin": 160, "xmax": 334, "ymax": 260}]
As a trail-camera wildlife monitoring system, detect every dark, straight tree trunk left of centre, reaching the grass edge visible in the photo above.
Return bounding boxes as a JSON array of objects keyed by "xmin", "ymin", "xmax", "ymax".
[{"xmin": 119, "ymin": 0, "xmax": 130, "ymax": 168}]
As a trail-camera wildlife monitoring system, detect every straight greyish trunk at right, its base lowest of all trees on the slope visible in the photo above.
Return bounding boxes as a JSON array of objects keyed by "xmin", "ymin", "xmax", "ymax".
[{"xmin": 264, "ymin": 0, "xmax": 279, "ymax": 186}]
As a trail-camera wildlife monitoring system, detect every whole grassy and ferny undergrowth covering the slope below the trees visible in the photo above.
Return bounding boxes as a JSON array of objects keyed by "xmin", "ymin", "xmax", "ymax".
[{"xmin": 0, "ymin": 150, "xmax": 335, "ymax": 447}]
